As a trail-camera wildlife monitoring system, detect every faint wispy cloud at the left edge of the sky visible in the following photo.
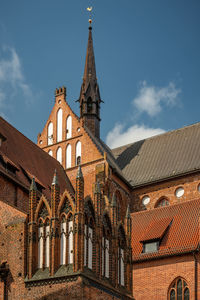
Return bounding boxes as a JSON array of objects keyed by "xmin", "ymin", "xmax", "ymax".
[{"xmin": 0, "ymin": 46, "xmax": 33, "ymax": 114}]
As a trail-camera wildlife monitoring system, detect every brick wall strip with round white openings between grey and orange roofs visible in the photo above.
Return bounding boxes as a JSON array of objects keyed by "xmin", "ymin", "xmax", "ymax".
[{"xmin": 132, "ymin": 174, "xmax": 200, "ymax": 211}]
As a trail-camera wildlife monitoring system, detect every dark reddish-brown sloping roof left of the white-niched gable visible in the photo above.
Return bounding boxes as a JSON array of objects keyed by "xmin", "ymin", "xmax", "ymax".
[{"xmin": 0, "ymin": 117, "xmax": 74, "ymax": 199}]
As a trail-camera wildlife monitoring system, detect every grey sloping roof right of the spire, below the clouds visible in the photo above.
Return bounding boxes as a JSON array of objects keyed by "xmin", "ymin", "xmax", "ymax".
[{"xmin": 112, "ymin": 123, "xmax": 200, "ymax": 187}]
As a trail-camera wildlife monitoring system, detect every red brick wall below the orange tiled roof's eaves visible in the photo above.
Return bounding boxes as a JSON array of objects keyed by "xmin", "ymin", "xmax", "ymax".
[{"xmin": 133, "ymin": 254, "xmax": 195, "ymax": 300}]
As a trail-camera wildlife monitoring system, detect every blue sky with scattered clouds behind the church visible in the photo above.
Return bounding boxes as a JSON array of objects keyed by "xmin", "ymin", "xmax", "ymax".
[{"xmin": 0, "ymin": 0, "xmax": 200, "ymax": 147}]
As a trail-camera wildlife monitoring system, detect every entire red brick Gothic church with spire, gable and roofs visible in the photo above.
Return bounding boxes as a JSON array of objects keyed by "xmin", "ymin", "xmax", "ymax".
[{"xmin": 0, "ymin": 21, "xmax": 200, "ymax": 300}]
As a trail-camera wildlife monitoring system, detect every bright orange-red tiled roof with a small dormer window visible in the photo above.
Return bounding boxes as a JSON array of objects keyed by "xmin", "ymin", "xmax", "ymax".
[{"xmin": 132, "ymin": 199, "xmax": 200, "ymax": 261}]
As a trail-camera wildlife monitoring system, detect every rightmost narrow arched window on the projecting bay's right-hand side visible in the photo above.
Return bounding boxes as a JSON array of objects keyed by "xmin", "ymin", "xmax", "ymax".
[{"xmin": 118, "ymin": 226, "xmax": 126, "ymax": 286}]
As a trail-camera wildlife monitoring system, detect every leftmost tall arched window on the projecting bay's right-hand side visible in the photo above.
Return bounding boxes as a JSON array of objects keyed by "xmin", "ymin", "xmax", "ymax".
[{"xmin": 84, "ymin": 201, "xmax": 95, "ymax": 269}]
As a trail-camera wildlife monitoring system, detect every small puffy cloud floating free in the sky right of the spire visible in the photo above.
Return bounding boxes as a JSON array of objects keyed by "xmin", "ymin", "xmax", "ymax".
[{"xmin": 132, "ymin": 81, "xmax": 181, "ymax": 117}]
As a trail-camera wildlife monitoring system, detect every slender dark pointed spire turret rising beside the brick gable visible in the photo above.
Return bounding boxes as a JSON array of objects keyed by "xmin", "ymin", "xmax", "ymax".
[{"xmin": 78, "ymin": 20, "xmax": 102, "ymax": 138}]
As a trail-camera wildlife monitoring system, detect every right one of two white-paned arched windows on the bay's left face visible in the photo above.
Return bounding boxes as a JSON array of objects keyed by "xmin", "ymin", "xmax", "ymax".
[{"xmin": 60, "ymin": 214, "xmax": 73, "ymax": 265}]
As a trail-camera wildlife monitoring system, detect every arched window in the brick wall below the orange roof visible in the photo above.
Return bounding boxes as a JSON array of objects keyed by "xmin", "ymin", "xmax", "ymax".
[{"xmin": 168, "ymin": 277, "xmax": 190, "ymax": 300}]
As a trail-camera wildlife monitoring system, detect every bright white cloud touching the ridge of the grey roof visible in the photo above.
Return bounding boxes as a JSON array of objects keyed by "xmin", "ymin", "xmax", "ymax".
[{"xmin": 106, "ymin": 124, "xmax": 165, "ymax": 149}]
